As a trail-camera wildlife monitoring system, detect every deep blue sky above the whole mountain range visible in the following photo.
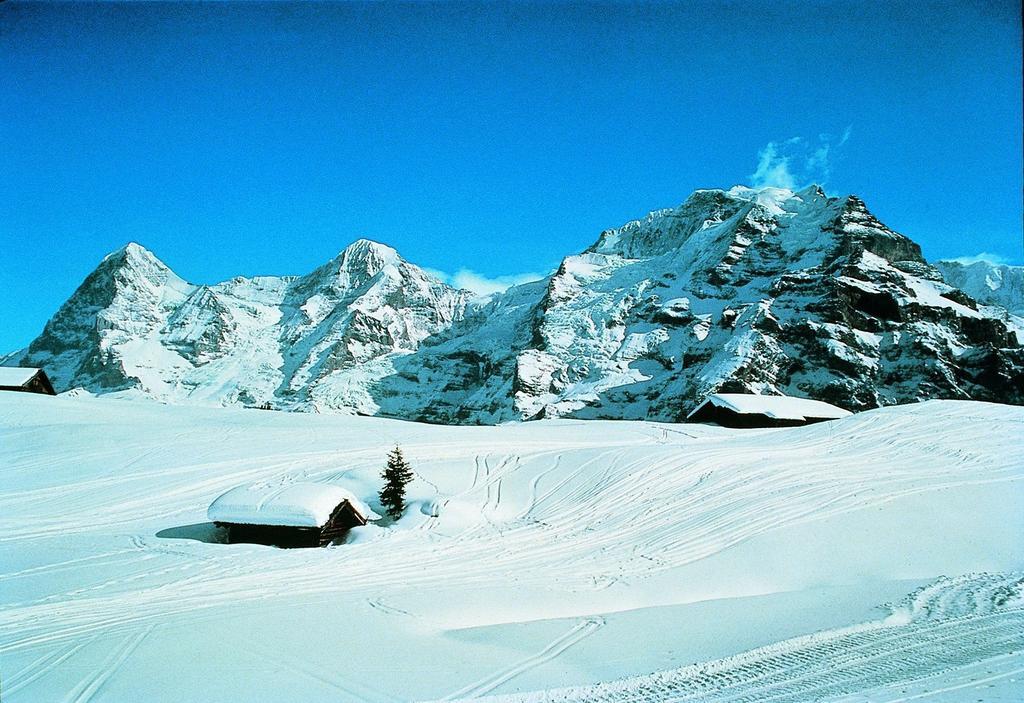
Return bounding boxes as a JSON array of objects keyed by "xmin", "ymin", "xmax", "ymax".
[{"xmin": 0, "ymin": 1, "xmax": 1022, "ymax": 350}]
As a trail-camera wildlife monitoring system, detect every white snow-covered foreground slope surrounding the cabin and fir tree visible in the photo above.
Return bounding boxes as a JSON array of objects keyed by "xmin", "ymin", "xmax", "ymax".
[{"xmin": 0, "ymin": 394, "xmax": 1024, "ymax": 702}]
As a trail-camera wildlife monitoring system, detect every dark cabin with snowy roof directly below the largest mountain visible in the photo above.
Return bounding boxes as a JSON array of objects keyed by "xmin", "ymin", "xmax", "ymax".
[{"xmin": 686, "ymin": 393, "xmax": 851, "ymax": 428}]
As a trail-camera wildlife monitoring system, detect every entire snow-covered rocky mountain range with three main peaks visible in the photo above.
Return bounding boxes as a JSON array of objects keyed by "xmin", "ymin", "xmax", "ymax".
[{"xmin": 5, "ymin": 186, "xmax": 1024, "ymax": 423}]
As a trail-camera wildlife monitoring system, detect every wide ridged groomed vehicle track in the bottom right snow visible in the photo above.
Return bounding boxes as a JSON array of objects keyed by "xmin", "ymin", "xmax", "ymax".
[{"xmin": 464, "ymin": 574, "xmax": 1024, "ymax": 703}]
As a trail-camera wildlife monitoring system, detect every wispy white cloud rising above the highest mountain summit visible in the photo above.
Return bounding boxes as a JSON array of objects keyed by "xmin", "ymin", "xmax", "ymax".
[{"xmin": 751, "ymin": 127, "xmax": 852, "ymax": 190}]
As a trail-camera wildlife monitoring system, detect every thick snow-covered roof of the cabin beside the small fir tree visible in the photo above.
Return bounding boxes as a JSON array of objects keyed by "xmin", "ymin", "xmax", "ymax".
[{"xmin": 206, "ymin": 483, "xmax": 380, "ymax": 527}]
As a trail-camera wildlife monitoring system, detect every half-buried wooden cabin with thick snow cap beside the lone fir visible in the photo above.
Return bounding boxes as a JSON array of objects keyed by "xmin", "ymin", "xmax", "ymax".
[{"xmin": 207, "ymin": 483, "xmax": 380, "ymax": 546}]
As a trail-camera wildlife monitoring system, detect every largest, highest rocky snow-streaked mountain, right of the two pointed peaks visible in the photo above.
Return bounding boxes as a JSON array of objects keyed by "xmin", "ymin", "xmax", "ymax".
[{"xmin": 382, "ymin": 187, "xmax": 1024, "ymax": 422}]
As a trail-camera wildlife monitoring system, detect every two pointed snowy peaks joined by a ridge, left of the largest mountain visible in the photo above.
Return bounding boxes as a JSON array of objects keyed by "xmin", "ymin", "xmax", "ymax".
[{"xmin": 6, "ymin": 239, "xmax": 471, "ymax": 412}]
